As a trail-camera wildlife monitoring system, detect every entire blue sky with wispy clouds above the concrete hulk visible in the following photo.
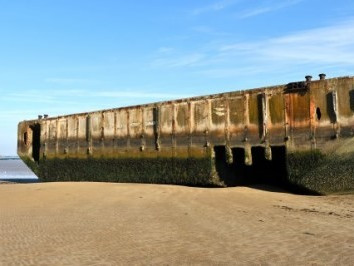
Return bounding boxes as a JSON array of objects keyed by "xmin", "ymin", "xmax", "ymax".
[{"xmin": 0, "ymin": 0, "xmax": 354, "ymax": 155}]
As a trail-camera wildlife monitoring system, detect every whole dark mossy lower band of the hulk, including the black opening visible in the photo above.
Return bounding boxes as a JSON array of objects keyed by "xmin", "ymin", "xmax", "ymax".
[{"xmin": 22, "ymin": 148, "xmax": 354, "ymax": 194}]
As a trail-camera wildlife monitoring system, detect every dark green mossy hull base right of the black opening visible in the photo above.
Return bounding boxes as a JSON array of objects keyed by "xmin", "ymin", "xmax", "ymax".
[{"xmin": 287, "ymin": 151, "xmax": 354, "ymax": 194}]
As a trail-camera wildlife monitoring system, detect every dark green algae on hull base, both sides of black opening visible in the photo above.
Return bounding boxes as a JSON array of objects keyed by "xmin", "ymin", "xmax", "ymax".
[{"xmin": 22, "ymin": 150, "xmax": 354, "ymax": 194}]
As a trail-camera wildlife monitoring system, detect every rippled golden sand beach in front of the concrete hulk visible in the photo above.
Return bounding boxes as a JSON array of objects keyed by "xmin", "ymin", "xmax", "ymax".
[{"xmin": 0, "ymin": 183, "xmax": 354, "ymax": 265}]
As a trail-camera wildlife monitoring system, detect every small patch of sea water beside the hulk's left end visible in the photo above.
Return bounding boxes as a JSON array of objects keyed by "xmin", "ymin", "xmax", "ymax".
[{"xmin": 0, "ymin": 157, "xmax": 38, "ymax": 182}]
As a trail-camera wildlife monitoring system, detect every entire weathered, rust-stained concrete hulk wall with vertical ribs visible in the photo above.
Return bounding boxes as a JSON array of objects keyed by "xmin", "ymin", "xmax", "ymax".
[{"xmin": 18, "ymin": 77, "xmax": 354, "ymax": 192}]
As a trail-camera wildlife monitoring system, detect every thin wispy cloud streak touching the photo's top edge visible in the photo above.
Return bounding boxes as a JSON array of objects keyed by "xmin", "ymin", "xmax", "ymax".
[{"xmin": 237, "ymin": 0, "xmax": 304, "ymax": 19}]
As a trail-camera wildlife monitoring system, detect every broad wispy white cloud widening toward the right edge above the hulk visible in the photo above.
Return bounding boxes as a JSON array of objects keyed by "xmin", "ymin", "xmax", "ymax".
[{"xmin": 151, "ymin": 18, "xmax": 354, "ymax": 78}]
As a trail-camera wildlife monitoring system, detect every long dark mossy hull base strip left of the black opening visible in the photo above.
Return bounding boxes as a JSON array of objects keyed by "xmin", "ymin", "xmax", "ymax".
[{"xmin": 26, "ymin": 158, "xmax": 222, "ymax": 186}]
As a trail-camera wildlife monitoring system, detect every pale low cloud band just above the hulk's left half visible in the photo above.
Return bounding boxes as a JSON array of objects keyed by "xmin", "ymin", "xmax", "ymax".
[{"xmin": 0, "ymin": 89, "xmax": 193, "ymax": 123}]
